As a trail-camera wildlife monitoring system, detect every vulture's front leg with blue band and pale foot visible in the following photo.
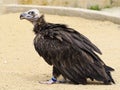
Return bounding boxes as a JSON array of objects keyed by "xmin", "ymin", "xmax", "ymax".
[{"xmin": 40, "ymin": 66, "xmax": 61, "ymax": 84}]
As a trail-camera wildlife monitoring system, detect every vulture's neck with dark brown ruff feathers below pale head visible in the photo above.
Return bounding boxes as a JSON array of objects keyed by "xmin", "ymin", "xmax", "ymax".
[{"xmin": 33, "ymin": 16, "xmax": 47, "ymax": 34}]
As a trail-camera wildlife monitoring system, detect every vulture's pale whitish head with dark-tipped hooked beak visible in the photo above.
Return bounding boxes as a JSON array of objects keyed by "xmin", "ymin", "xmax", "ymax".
[{"xmin": 20, "ymin": 9, "xmax": 44, "ymax": 24}]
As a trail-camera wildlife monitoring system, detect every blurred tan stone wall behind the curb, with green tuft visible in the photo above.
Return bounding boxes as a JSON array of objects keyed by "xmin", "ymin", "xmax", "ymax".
[{"xmin": 0, "ymin": 0, "xmax": 120, "ymax": 10}]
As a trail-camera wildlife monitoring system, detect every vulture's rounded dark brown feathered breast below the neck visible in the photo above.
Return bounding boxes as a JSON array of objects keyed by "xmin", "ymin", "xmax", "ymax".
[{"xmin": 34, "ymin": 34, "xmax": 70, "ymax": 65}]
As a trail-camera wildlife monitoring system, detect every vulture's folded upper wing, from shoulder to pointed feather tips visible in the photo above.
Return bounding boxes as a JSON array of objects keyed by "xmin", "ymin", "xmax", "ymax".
[{"xmin": 49, "ymin": 27, "xmax": 102, "ymax": 59}]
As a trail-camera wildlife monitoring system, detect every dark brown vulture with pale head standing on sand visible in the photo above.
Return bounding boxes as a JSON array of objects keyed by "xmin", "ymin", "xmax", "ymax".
[{"xmin": 20, "ymin": 9, "xmax": 115, "ymax": 85}]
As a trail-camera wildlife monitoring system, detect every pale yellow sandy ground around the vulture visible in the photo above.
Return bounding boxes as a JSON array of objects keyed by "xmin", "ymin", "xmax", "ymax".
[{"xmin": 0, "ymin": 13, "xmax": 120, "ymax": 90}]
